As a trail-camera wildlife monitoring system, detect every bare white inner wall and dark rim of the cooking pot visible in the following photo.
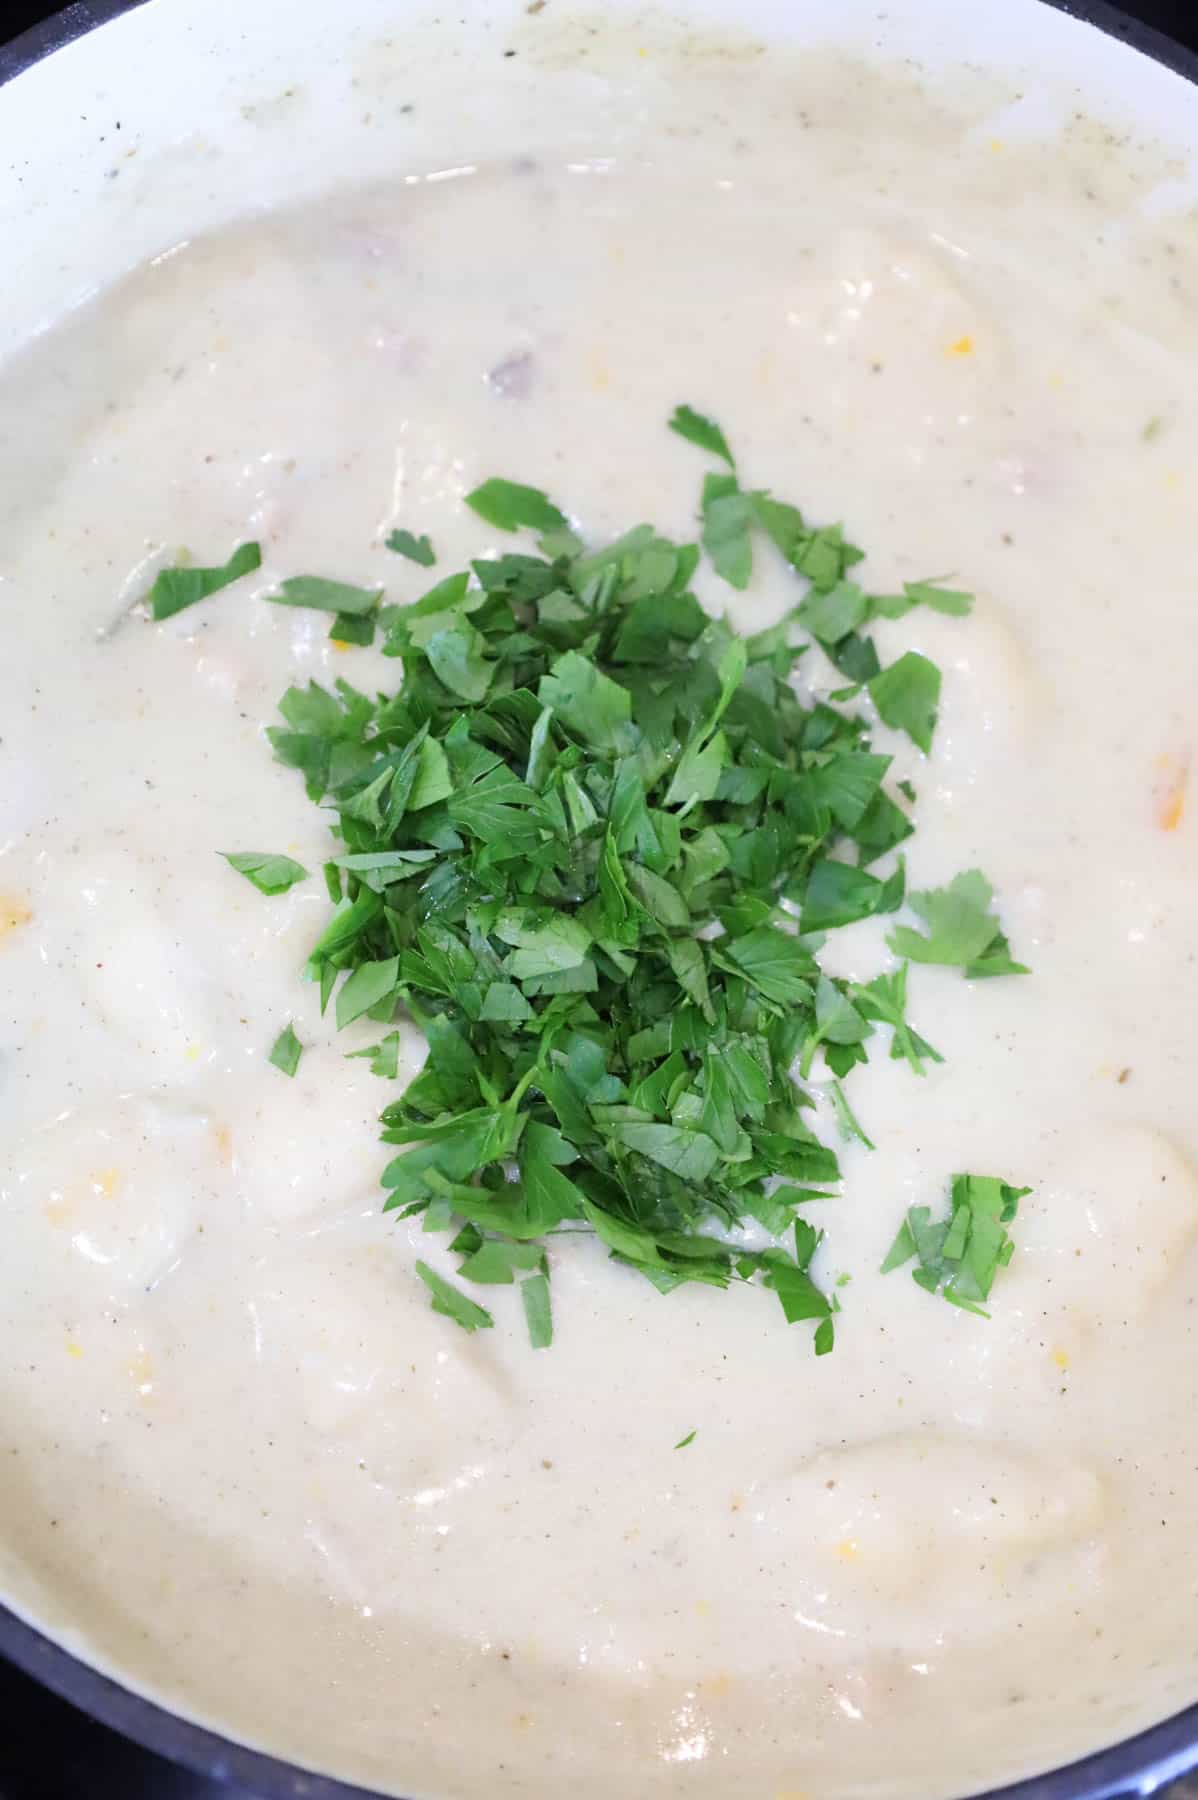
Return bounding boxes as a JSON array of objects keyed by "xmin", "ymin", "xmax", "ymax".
[{"xmin": 0, "ymin": 0, "xmax": 1198, "ymax": 1800}]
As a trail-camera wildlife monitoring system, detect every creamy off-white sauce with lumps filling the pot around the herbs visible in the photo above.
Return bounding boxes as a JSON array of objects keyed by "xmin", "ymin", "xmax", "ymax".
[{"xmin": 0, "ymin": 38, "xmax": 1198, "ymax": 1800}]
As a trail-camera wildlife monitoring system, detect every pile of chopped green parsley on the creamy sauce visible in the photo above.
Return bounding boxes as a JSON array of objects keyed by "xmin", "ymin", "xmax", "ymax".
[{"xmin": 197, "ymin": 407, "xmax": 1020, "ymax": 1354}]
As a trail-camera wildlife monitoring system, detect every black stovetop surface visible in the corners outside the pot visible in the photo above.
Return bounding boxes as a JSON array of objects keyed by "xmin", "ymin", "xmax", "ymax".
[{"xmin": 0, "ymin": 0, "xmax": 1198, "ymax": 1800}]
